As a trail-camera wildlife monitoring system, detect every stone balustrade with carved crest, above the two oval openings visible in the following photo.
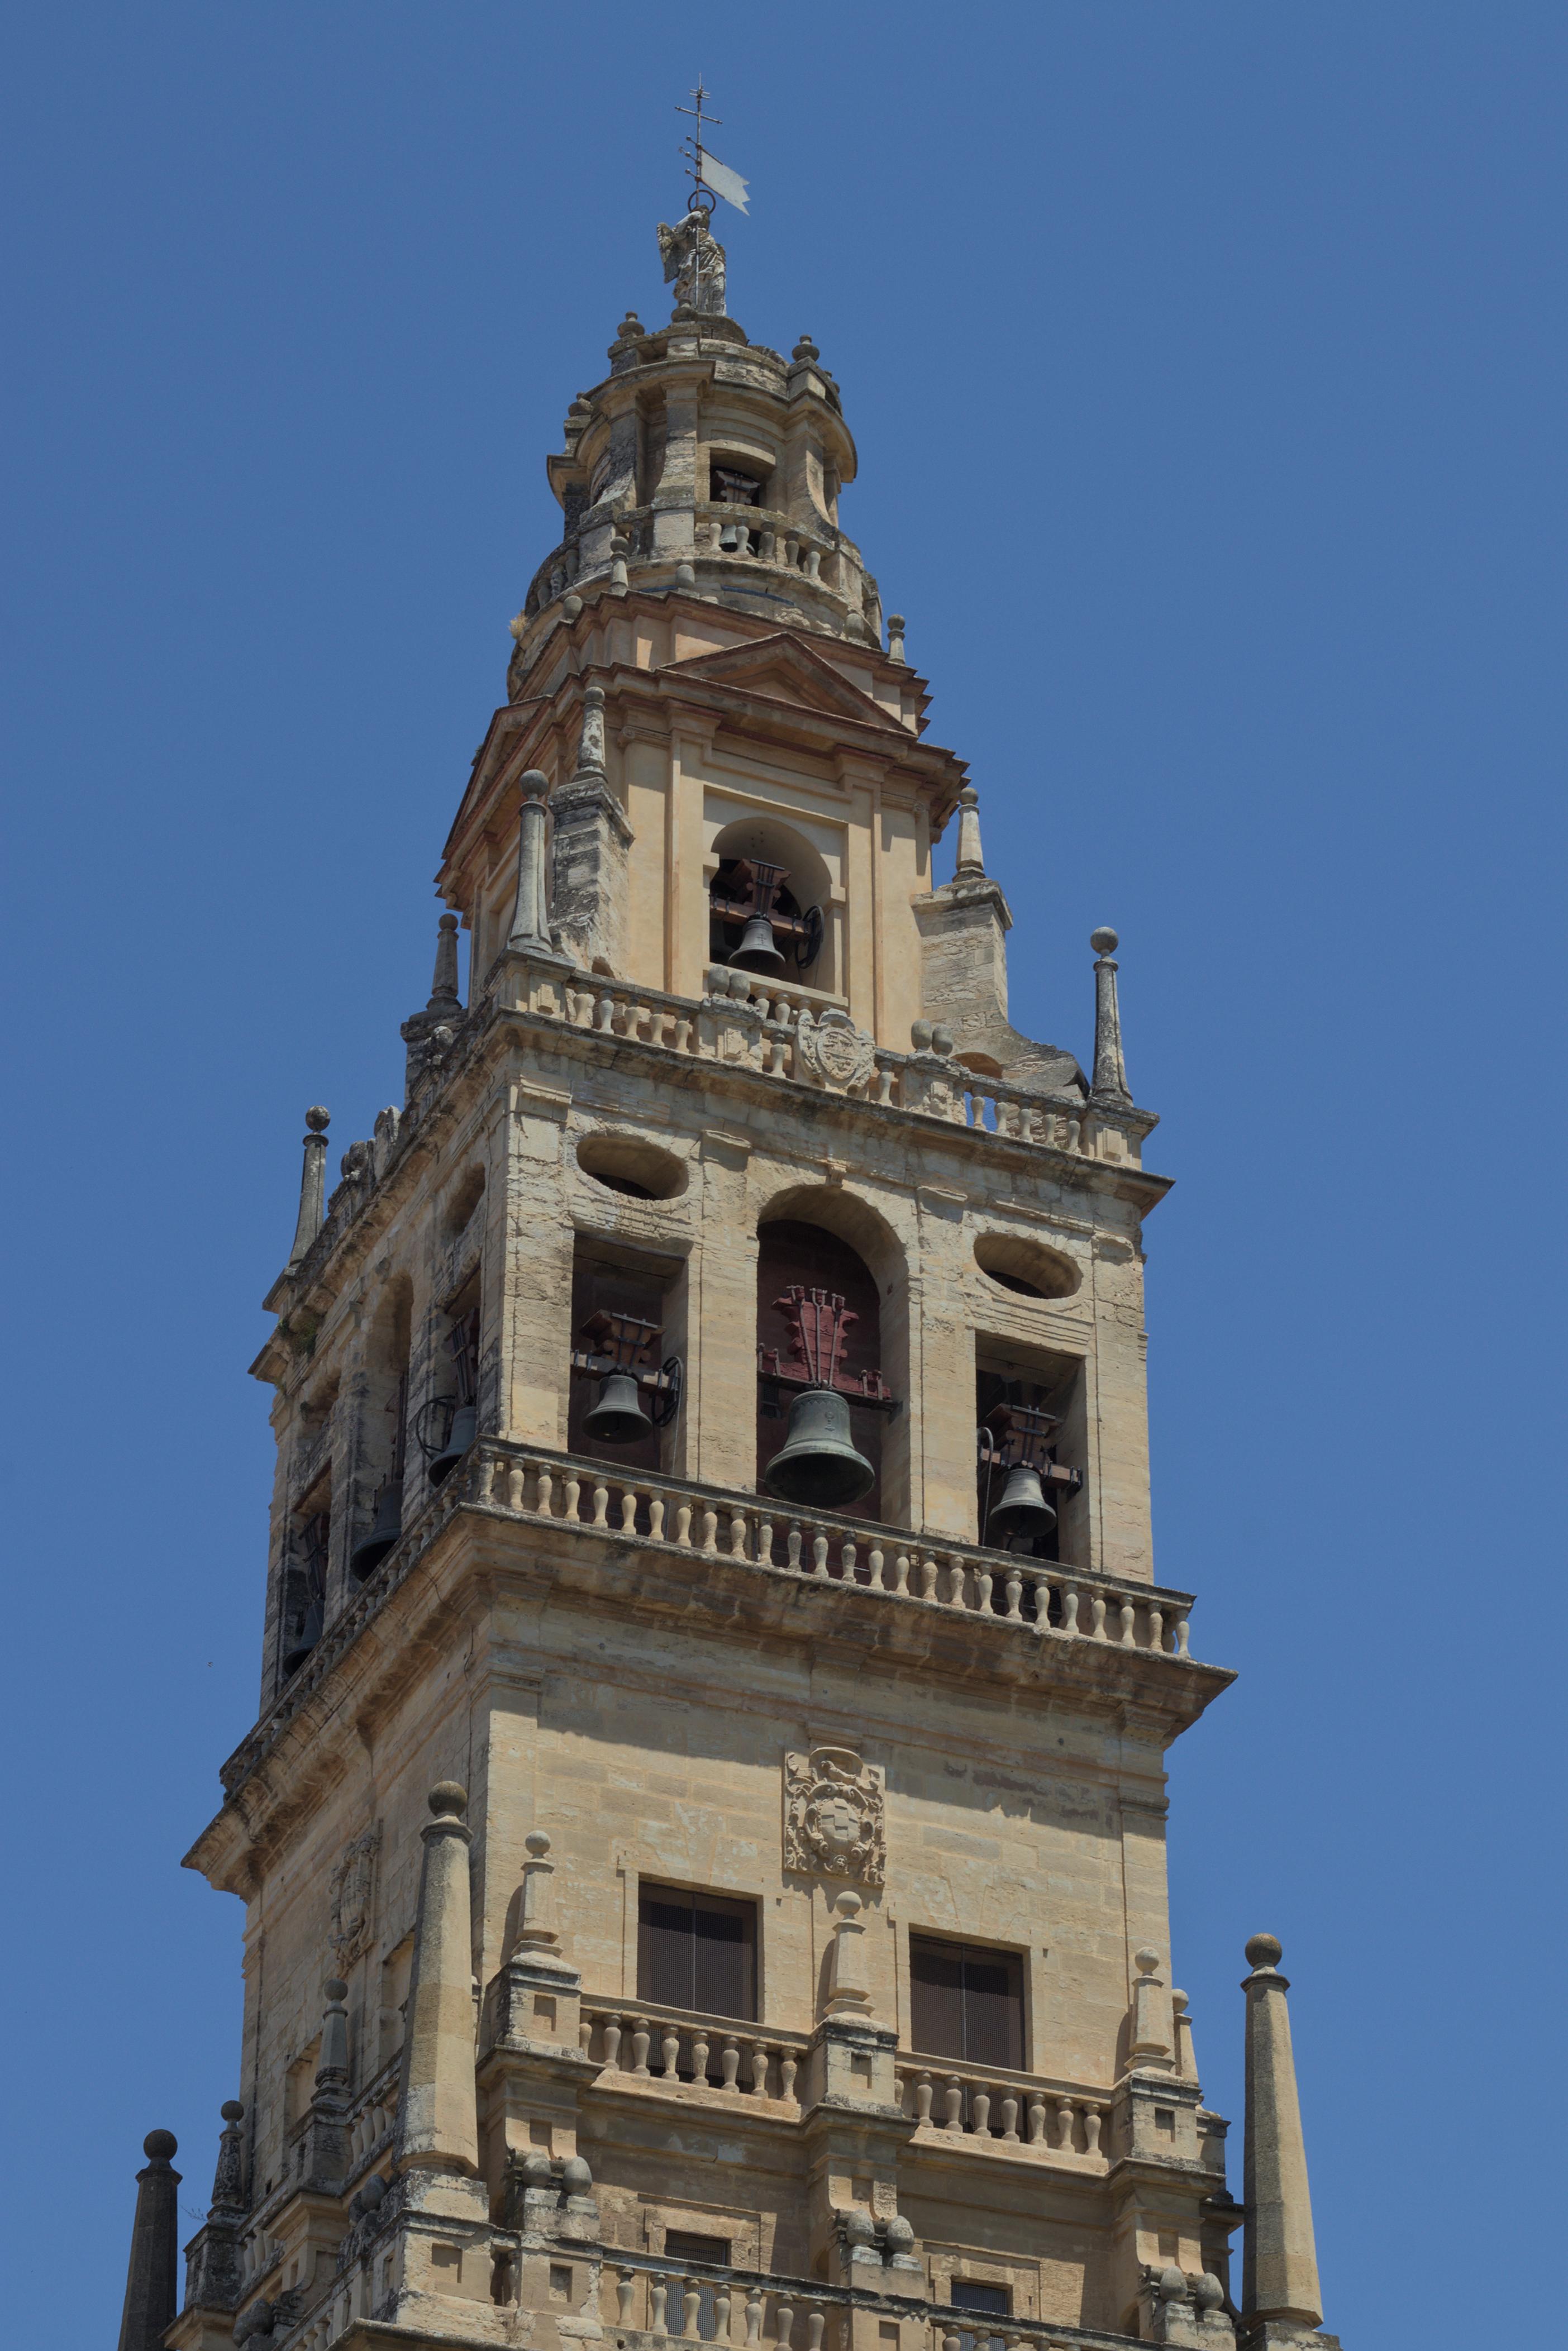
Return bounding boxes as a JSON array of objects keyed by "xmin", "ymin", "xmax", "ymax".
[{"xmin": 489, "ymin": 955, "xmax": 1154, "ymax": 1166}]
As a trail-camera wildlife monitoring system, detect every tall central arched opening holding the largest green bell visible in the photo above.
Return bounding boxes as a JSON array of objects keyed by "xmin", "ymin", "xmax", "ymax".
[{"xmin": 757, "ymin": 1194, "xmax": 907, "ymax": 1521}]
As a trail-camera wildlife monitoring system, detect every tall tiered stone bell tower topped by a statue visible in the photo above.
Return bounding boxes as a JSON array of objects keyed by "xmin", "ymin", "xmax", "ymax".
[{"xmin": 144, "ymin": 233, "xmax": 1331, "ymax": 2351}]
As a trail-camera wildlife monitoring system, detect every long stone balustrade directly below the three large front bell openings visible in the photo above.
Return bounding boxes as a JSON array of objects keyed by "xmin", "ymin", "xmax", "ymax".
[{"xmin": 472, "ymin": 1437, "xmax": 1192, "ymax": 1665}]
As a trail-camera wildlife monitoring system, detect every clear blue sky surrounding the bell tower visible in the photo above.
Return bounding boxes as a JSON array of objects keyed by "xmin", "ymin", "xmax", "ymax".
[{"xmin": 0, "ymin": 0, "xmax": 1568, "ymax": 2351}]
